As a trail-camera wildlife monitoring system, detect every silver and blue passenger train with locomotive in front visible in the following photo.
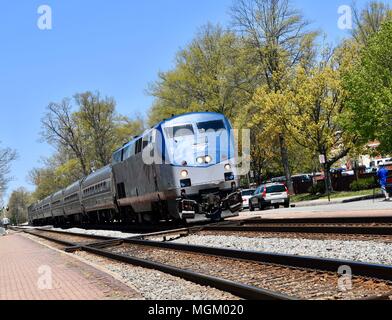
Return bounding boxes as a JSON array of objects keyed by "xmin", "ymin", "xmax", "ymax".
[{"xmin": 29, "ymin": 113, "xmax": 242, "ymax": 225}]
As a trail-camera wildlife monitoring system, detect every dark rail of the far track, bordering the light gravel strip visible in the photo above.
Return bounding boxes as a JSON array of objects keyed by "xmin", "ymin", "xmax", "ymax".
[{"xmin": 202, "ymin": 225, "xmax": 392, "ymax": 236}]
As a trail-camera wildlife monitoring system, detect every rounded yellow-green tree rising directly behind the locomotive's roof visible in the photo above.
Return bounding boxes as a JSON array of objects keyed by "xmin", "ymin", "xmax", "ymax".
[{"xmin": 149, "ymin": 25, "xmax": 257, "ymax": 125}]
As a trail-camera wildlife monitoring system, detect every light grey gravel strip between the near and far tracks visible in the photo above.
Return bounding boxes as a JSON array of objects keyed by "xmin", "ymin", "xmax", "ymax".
[{"xmin": 173, "ymin": 235, "xmax": 392, "ymax": 265}]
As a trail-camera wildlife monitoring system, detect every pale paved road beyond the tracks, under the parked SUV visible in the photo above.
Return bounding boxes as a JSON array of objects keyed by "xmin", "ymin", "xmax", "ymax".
[{"xmin": 236, "ymin": 199, "xmax": 392, "ymax": 218}]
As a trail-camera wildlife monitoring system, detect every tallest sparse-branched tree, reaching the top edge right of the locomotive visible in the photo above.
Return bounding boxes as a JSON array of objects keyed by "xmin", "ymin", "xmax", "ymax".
[{"xmin": 231, "ymin": 0, "xmax": 317, "ymax": 192}]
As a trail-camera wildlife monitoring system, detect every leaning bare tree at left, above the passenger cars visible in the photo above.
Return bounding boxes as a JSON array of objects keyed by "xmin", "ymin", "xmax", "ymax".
[{"xmin": 41, "ymin": 99, "xmax": 89, "ymax": 175}]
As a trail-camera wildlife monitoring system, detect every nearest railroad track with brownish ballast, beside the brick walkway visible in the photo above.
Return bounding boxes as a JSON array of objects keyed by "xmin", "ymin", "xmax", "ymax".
[{"xmin": 17, "ymin": 230, "xmax": 392, "ymax": 300}]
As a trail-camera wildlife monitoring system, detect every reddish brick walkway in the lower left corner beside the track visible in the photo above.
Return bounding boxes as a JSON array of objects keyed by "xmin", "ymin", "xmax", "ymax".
[{"xmin": 0, "ymin": 234, "xmax": 140, "ymax": 300}]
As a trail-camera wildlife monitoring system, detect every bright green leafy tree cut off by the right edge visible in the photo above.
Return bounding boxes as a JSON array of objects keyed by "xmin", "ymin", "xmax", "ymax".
[{"xmin": 344, "ymin": 21, "xmax": 392, "ymax": 154}]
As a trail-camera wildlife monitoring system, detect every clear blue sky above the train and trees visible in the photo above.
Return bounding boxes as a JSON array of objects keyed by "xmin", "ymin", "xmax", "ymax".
[{"xmin": 0, "ymin": 0, "xmax": 376, "ymax": 200}]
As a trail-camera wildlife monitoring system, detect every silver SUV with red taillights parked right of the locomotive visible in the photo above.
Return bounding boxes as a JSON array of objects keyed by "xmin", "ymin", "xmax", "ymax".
[{"xmin": 249, "ymin": 183, "xmax": 290, "ymax": 211}]
